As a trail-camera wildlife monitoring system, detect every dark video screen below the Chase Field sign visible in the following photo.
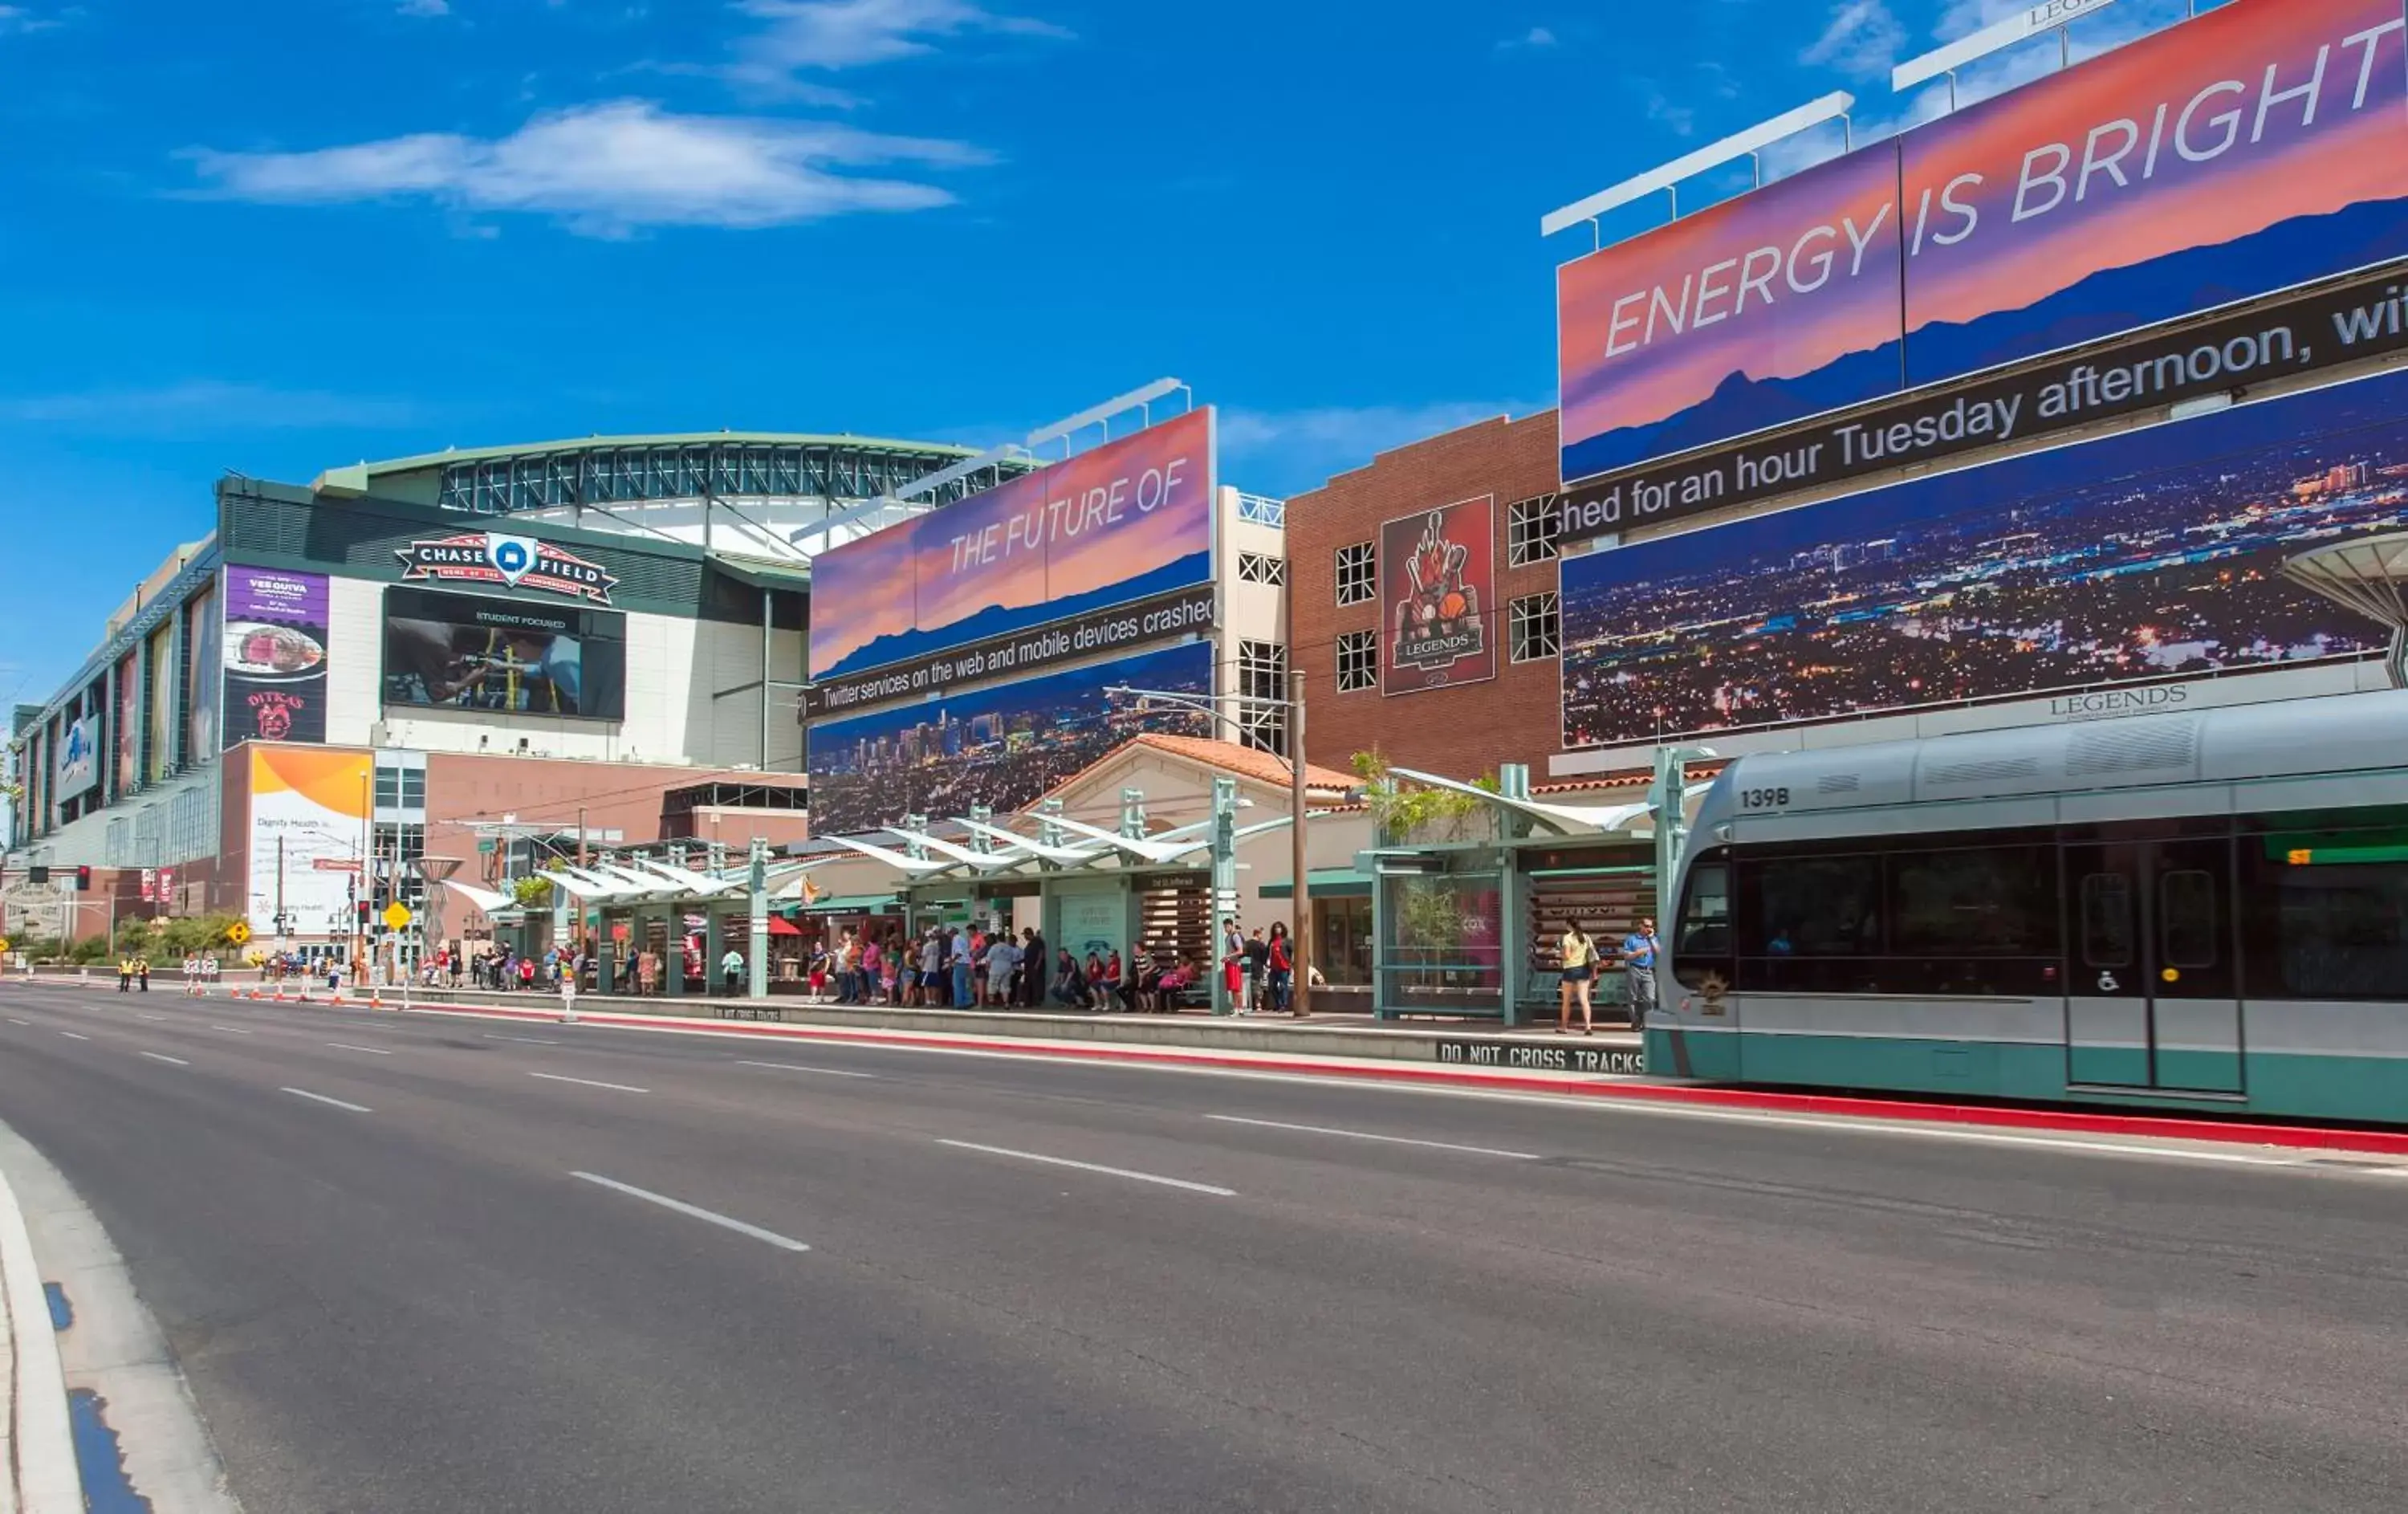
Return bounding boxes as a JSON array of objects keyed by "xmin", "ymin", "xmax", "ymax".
[{"xmin": 383, "ymin": 588, "xmax": 626, "ymax": 720}]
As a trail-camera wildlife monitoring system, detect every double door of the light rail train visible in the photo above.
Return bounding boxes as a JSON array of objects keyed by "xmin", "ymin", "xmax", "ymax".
[{"xmin": 2066, "ymin": 840, "xmax": 2242, "ymax": 1093}]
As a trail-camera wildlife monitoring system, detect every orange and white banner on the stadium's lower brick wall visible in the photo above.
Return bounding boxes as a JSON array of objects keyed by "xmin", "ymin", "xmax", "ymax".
[{"xmin": 246, "ymin": 744, "xmax": 373, "ymax": 936}]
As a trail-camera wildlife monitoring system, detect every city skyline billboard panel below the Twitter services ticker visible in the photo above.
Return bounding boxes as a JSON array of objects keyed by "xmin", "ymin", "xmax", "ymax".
[{"xmin": 809, "ymin": 641, "xmax": 1214, "ymax": 835}]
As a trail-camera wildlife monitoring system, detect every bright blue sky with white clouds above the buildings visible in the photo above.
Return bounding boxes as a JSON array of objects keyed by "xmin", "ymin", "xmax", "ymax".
[{"xmin": 0, "ymin": 0, "xmax": 2179, "ymax": 703}]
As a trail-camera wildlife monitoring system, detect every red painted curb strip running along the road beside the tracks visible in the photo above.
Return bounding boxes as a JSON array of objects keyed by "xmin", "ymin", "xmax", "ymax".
[{"xmin": 311, "ymin": 1003, "xmax": 2408, "ymax": 1155}]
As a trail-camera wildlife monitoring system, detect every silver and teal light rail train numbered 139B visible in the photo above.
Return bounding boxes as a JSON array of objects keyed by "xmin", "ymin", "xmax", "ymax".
[{"xmin": 1647, "ymin": 691, "xmax": 2408, "ymax": 1124}]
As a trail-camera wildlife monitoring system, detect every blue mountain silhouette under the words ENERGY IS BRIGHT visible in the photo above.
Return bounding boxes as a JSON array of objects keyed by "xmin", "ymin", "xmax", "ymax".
[{"xmin": 1563, "ymin": 200, "xmax": 2408, "ymax": 479}]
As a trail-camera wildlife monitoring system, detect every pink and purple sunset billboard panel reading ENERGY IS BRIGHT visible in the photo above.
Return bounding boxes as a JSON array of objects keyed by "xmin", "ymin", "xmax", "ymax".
[{"xmin": 1558, "ymin": 0, "xmax": 2408, "ymax": 479}]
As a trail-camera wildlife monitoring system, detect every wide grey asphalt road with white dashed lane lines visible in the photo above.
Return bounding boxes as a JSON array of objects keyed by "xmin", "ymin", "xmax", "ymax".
[{"xmin": 0, "ymin": 984, "xmax": 2408, "ymax": 1514}]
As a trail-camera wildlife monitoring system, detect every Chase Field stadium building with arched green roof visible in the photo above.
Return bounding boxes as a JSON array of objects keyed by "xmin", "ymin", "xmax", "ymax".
[{"xmin": 7, "ymin": 431, "xmax": 1028, "ymax": 948}]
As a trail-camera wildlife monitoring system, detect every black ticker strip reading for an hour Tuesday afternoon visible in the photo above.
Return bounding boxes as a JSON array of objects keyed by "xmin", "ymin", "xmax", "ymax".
[{"xmin": 1558, "ymin": 267, "xmax": 2408, "ymax": 542}]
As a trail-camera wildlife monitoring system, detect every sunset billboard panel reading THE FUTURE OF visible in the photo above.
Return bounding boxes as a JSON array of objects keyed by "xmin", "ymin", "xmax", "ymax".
[{"xmin": 809, "ymin": 407, "xmax": 1214, "ymax": 703}]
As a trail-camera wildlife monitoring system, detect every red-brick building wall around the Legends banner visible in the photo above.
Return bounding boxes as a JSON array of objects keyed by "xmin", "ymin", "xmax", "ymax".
[{"xmin": 1288, "ymin": 409, "xmax": 1563, "ymax": 779}]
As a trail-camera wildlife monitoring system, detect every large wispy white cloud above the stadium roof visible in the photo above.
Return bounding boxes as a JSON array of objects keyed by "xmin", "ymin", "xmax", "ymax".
[{"xmin": 181, "ymin": 101, "xmax": 990, "ymax": 236}]
